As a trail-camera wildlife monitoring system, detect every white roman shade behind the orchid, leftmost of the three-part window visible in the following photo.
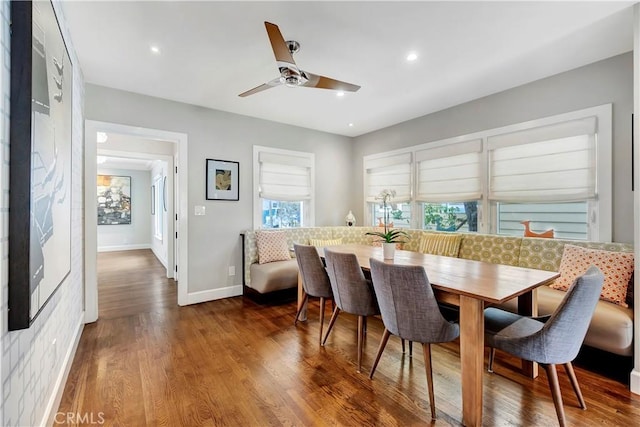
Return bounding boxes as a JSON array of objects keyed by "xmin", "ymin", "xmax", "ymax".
[{"xmin": 364, "ymin": 153, "xmax": 411, "ymax": 203}]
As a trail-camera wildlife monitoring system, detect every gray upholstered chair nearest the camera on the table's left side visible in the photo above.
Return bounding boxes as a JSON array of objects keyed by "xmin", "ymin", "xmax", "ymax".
[{"xmin": 369, "ymin": 258, "xmax": 460, "ymax": 419}]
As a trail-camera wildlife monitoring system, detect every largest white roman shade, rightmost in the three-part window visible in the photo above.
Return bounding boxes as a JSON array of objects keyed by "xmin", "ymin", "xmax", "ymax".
[{"xmin": 488, "ymin": 117, "xmax": 596, "ymax": 202}]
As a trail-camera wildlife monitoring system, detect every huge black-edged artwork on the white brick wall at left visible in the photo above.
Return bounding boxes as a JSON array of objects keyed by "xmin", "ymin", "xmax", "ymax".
[{"xmin": 8, "ymin": 2, "xmax": 73, "ymax": 330}]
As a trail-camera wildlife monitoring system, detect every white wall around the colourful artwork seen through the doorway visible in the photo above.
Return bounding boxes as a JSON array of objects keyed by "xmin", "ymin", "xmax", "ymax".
[{"xmin": 98, "ymin": 168, "xmax": 152, "ymax": 252}]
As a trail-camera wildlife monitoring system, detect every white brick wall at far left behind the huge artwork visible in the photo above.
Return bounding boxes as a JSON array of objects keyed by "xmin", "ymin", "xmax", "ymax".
[{"xmin": 0, "ymin": 1, "xmax": 84, "ymax": 426}]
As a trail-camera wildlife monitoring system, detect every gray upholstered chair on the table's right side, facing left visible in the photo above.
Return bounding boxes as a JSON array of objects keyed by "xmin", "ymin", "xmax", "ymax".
[{"xmin": 484, "ymin": 266, "xmax": 604, "ymax": 426}]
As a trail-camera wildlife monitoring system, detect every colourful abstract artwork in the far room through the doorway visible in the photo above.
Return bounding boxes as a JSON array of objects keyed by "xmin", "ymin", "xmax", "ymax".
[{"xmin": 98, "ymin": 175, "xmax": 131, "ymax": 225}]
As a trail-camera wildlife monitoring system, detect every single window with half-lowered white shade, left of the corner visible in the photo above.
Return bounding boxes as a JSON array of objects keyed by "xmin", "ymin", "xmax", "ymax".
[{"xmin": 253, "ymin": 146, "xmax": 315, "ymax": 228}]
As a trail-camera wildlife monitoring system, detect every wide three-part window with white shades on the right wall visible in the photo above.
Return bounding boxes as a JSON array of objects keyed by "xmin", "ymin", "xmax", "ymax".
[{"xmin": 363, "ymin": 104, "xmax": 612, "ymax": 241}]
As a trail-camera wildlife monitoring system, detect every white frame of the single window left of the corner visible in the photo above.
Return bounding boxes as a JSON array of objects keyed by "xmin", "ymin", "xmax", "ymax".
[{"xmin": 253, "ymin": 145, "xmax": 316, "ymax": 229}]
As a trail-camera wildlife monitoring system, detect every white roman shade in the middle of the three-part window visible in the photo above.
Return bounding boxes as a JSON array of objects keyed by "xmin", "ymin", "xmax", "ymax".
[{"xmin": 416, "ymin": 139, "xmax": 482, "ymax": 203}]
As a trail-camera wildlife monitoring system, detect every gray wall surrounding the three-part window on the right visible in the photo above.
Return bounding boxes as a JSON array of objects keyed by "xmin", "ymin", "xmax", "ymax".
[{"xmin": 351, "ymin": 53, "xmax": 640, "ymax": 243}]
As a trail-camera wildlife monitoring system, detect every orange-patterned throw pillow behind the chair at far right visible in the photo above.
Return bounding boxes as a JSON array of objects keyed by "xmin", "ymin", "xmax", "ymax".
[{"xmin": 550, "ymin": 245, "xmax": 633, "ymax": 307}]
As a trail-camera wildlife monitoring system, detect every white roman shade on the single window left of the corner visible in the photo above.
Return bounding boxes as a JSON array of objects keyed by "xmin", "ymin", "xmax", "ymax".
[{"xmin": 258, "ymin": 151, "xmax": 313, "ymax": 201}]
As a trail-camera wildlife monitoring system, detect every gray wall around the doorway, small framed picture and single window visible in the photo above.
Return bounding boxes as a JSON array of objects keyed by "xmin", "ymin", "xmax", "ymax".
[{"xmin": 85, "ymin": 84, "xmax": 356, "ymax": 293}]
